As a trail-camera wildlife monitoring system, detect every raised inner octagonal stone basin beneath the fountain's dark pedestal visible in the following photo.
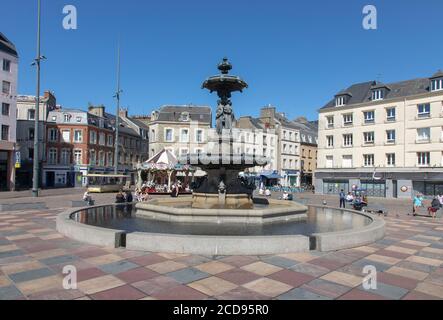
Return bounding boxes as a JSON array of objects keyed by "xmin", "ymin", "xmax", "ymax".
[{"xmin": 136, "ymin": 194, "xmax": 308, "ymax": 224}]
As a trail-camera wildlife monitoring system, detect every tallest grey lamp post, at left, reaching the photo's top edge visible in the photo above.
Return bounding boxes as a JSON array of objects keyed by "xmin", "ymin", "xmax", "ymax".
[{"xmin": 32, "ymin": 0, "xmax": 46, "ymax": 197}]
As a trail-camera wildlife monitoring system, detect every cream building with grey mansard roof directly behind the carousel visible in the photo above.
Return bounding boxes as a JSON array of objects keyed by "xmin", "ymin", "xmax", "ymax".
[{"xmin": 141, "ymin": 105, "xmax": 212, "ymax": 157}]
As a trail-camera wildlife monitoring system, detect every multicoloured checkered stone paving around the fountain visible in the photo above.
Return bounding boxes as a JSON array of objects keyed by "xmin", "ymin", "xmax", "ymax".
[{"xmin": 0, "ymin": 194, "xmax": 443, "ymax": 300}]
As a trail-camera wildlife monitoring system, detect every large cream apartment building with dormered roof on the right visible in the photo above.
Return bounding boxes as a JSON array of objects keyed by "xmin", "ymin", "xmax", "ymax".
[{"xmin": 315, "ymin": 71, "xmax": 443, "ymax": 198}]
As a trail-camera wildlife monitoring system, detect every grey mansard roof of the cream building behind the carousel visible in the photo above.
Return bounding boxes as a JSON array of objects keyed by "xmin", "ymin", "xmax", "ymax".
[{"xmin": 152, "ymin": 106, "xmax": 212, "ymax": 124}]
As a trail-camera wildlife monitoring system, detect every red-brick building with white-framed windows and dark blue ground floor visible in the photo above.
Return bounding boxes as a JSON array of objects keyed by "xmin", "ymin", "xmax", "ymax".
[{"xmin": 42, "ymin": 109, "xmax": 115, "ymax": 188}]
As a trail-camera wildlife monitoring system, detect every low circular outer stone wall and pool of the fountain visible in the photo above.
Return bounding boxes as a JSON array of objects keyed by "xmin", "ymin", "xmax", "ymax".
[{"xmin": 57, "ymin": 205, "xmax": 385, "ymax": 255}]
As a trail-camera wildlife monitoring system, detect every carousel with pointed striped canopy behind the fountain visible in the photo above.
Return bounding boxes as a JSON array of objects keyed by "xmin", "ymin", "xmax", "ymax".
[{"xmin": 137, "ymin": 149, "xmax": 201, "ymax": 194}]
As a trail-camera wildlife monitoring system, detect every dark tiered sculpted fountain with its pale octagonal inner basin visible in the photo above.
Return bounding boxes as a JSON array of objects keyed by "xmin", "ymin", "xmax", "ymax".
[{"xmin": 137, "ymin": 58, "xmax": 307, "ymax": 223}]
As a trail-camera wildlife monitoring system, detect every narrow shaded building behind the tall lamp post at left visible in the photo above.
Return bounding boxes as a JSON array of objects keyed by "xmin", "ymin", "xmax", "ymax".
[{"xmin": 15, "ymin": 91, "xmax": 58, "ymax": 189}]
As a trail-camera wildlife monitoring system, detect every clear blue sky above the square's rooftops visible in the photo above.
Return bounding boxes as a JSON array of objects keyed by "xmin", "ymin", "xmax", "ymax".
[{"xmin": 0, "ymin": 0, "xmax": 443, "ymax": 119}]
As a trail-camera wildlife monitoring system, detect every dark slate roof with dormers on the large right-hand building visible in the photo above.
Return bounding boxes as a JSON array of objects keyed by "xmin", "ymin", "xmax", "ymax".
[{"xmin": 321, "ymin": 71, "xmax": 443, "ymax": 109}]
